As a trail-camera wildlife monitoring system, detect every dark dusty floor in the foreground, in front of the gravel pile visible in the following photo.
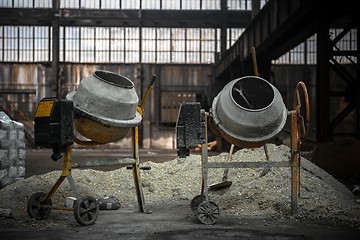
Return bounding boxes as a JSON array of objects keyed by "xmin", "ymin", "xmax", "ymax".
[{"xmin": 0, "ymin": 204, "xmax": 360, "ymax": 240}]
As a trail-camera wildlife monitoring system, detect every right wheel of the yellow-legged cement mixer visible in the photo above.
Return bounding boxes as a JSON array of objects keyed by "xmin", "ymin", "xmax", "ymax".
[{"xmin": 74, "ymin": 196, "xmax": 99, "ymax": 226}]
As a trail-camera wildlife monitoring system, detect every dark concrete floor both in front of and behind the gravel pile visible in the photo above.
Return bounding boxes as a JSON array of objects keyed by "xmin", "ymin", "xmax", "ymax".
[{"xmin": 0, "ymin": 147, "xmax": 360, "ymax": 240}]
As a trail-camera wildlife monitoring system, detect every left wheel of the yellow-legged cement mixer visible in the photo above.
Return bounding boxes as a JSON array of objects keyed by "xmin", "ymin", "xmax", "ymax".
[{"xmin": 27, "ymin": 192, "xmax": 52, "ymax": 220}]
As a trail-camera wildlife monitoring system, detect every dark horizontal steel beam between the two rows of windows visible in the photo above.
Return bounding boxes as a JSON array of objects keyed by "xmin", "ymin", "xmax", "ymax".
[{"xmin": 0, "ymin": 8, "xmax": 251, "ymax": 28}]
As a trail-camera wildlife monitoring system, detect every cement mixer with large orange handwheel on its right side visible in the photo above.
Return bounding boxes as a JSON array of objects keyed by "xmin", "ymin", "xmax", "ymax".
[{"xmin": 176, "ymin": 76, "xmax": 310, "ymax": 224}]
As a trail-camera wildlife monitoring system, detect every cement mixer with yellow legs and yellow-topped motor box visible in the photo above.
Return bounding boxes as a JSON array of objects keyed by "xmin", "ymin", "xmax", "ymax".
[{"xmin": 27, "ymin": 70, "xmax": 156, "ymax": 226}]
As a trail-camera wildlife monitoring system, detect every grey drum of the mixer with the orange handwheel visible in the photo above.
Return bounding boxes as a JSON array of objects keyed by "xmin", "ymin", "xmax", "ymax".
[{"xmin": 210, "ymin": 76, "xmax": 287, "ymax": 148}]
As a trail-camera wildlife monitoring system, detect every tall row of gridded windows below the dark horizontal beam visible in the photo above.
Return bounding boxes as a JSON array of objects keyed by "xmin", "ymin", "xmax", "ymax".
[{"xmin": 0, "ymin": 26, "xmax": 357, "ymax": 64}]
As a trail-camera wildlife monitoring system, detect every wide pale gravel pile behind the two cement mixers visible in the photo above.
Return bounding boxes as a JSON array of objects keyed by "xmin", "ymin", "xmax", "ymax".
[{"xmin": 0, "ymin": 144, "xmax": 360, "ymax": 228}]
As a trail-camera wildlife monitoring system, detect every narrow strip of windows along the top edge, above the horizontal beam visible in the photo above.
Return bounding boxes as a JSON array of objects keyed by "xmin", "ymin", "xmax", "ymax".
[{"xmin": 0, "ymin": 0, "xmax": 267, "ymax": 10}]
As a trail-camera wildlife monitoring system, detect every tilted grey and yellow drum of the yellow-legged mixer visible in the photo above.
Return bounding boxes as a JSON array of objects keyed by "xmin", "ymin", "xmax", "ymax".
[{"xmin": 66, "ymin": 70, "xmax": 142, "ymax": 144}]
